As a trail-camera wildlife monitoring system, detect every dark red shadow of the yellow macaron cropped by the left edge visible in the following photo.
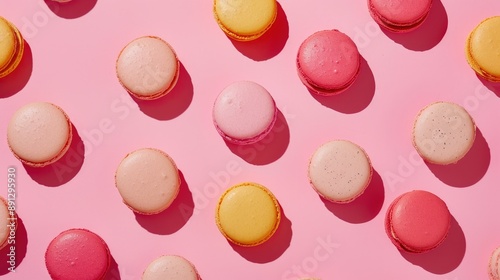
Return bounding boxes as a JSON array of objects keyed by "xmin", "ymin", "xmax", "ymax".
[{"xmin": 0, "ymin": 40, "xmax": 33, "ymax": 98}]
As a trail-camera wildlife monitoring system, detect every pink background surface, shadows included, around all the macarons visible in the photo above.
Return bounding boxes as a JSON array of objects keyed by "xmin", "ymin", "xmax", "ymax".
[{"xmin": 0, "ymin": 0, "xmax": 500, "ymax": 280}]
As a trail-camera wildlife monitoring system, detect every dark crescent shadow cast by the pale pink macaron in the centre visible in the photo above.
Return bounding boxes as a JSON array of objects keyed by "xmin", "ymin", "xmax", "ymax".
[{"xmin": 225, "ymin": 109, "xmax": 290, "ymax": 165}]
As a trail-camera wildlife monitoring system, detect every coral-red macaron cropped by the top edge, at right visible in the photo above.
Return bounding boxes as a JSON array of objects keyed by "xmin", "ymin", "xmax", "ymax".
[{"xmin": 368, "ymin": 0, "xmax": 432, "ymax": 32}]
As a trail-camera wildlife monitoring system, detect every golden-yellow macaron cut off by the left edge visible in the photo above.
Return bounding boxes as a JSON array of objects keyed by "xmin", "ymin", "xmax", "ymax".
[{"xmin": 0, "ymin": 17, "xmax": 24, "ymax": 78}]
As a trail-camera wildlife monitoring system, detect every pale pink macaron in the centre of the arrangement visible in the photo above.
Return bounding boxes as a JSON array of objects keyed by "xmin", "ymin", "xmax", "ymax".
[{"xmin": 212, "ymin": 81, "xmax": 278, "ymax": 145}]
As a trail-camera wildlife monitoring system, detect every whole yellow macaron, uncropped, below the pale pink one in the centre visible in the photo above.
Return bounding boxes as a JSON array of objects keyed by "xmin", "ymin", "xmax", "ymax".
[{"xmin": 215, "ymin": 182, "xmax": 281, "ymax": 247}]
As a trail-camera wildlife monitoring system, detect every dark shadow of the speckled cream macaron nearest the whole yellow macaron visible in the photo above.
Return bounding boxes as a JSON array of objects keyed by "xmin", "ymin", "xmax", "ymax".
[{"xmin": 320, "ymin": 170, "xmax": 385, "ymax": 224}]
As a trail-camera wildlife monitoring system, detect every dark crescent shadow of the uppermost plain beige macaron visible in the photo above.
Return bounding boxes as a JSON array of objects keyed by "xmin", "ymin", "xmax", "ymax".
[{"xmin": 131, "ymin": 62, "xmax": 194, "ymax": 120}]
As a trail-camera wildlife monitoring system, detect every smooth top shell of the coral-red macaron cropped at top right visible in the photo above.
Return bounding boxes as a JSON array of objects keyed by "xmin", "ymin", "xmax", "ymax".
[{"xmin": 368, "ymin": 0, "xmax": 439, "ymax": 25}]
